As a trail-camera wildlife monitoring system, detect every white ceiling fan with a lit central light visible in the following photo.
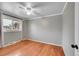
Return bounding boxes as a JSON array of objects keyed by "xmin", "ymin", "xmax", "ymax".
[{"xmin": 19, "ymin": 2, "xmax": 41, "ymax": 16}]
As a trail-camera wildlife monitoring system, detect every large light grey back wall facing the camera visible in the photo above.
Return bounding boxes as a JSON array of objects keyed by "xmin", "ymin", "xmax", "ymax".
[{"xmin": 29, "ymin": 15, "xmax": 62, "ymax": 45}]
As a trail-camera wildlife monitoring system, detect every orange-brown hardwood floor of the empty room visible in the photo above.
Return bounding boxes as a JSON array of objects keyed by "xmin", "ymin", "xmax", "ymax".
[{"xmin": 0, "ymin": 40, "xmax": 64, "ymax": 56}]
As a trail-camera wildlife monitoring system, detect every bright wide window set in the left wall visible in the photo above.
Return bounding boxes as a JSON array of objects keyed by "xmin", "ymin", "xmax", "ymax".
[{"xmin": 2, "ymin": 19, "xmax": 22, "ymax": 31}]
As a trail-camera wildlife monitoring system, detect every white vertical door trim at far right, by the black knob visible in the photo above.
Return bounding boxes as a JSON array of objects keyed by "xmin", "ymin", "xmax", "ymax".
[{"xmin": 75, "ymin": 2, "xmax": 79, "ymax": 56}]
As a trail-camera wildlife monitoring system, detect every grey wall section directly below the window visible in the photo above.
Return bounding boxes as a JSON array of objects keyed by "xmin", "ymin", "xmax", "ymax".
[{"xmin": 3, "ymin": 31, "xmax": 22, "ymax": 45}]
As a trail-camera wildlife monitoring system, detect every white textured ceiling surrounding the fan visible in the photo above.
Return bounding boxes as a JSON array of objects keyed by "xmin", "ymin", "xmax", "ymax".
[{"xmin": 0, "ymin": 2, "xmax": 65, "ymax": 19}]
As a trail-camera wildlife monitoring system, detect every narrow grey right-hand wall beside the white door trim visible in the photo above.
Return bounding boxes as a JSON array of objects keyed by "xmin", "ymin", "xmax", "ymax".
[{"xmin": 63, "ymin": 2, "xmax": 75, "ymax": 56}]
